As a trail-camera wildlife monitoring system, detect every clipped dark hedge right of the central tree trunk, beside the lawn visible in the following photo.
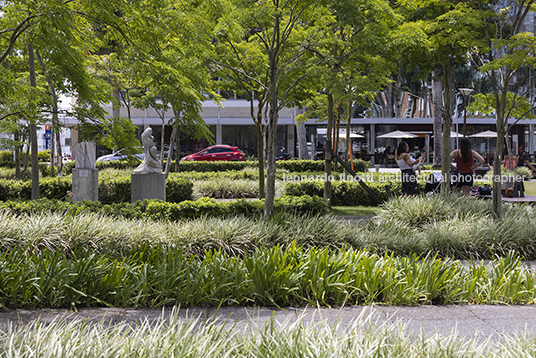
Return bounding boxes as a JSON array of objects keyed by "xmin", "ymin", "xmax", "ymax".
[{"xmin": 284, "ymin": 180, "xmax": 426, "ymax": 206}]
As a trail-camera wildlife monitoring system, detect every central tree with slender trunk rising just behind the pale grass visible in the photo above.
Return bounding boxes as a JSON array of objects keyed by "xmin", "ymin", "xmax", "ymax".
[{"xmin": 211, "ymin": 0, "xmax": 324, "ymax": 219}]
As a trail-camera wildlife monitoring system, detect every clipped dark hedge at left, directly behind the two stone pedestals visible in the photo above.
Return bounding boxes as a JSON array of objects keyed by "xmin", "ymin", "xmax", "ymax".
[{"xmin": 0, "ymin": 176, "xmax": 193, "ymax": 204}]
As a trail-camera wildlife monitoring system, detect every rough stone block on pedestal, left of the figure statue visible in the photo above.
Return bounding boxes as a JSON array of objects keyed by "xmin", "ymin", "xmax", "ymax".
[{"xmin": 72, "ymin": 142, "xmax": 99, "ymax": 203}]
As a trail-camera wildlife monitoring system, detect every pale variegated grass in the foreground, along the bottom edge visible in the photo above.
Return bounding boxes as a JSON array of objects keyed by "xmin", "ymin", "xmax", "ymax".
[{"xmin": 0, "ymin": 313, "xmax": 508, "ymax": 358}]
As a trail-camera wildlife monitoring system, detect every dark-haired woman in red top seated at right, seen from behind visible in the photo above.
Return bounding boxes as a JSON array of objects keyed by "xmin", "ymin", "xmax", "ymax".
[{"xmin": 450, "ymin": 138, "xmax": 484, "ymax": 195}]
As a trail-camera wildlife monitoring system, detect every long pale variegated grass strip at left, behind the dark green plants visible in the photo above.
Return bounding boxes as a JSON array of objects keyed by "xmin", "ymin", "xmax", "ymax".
[{"xmin": 0, "ymin": 210, "xmax": 354, "ymax": 256}]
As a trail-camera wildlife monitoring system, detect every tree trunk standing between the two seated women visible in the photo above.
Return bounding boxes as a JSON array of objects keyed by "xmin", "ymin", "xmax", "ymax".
[{"xmin": 441, "ymin": 62, "xmax": 452, "ymax": 195}]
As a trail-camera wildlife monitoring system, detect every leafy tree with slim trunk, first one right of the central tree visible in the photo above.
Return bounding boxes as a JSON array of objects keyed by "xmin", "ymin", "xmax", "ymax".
[{"xmin": 315, "ymin": 0, "xmax": 397, "ymax": 203}]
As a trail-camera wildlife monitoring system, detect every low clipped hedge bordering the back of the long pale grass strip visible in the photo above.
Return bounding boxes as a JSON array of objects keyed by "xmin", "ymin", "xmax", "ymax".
[{"xmin": 0, "ymin": 195, "xmax": 328, "ymax": 221}]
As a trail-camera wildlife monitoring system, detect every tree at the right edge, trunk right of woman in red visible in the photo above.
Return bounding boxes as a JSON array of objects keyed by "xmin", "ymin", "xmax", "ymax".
[{"xmin": 472, "ymin": 0, "xmax": 536, "ymax": 219}]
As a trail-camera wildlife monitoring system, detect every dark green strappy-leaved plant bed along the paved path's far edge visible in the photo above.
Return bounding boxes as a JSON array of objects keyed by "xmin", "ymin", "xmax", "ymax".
[{"xmin": 0, "ymin": 243, "xmax": 536, "ymax": 309}]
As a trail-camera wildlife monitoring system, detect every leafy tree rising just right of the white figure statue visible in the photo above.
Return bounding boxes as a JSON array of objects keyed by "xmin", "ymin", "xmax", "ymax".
[{"xmin": 125, "ymin": 0, "xmax": 218, "ymax": 175}]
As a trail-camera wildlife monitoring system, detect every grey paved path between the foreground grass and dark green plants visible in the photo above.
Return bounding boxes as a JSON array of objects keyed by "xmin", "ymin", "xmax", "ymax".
[{"xmin": 0, "ymin": 305, "xmax": 536, "ymax": 342}]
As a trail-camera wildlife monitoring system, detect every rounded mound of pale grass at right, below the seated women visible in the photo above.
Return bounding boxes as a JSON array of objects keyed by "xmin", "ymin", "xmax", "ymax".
[{"xmin": 366, "ymin": 195, "xmax": 536, "ymax": 259}]
